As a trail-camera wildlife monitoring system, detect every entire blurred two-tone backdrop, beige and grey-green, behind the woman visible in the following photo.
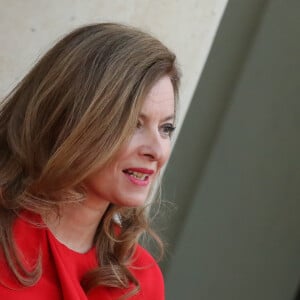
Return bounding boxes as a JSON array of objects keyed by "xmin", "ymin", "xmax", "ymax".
[{"xmin": 0, "ymin": 0, "xmax": 300, "ymax": 300}]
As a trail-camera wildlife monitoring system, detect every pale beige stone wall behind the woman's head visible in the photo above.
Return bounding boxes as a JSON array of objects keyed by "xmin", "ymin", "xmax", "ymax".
[{"xmin": 0, "ymin": 0, "xmax": 227, "ymax": 125}]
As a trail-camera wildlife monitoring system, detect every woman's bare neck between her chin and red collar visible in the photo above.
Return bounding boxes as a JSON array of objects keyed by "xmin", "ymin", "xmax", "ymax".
[{"xmin": 43, "ymin": 201, "xmax": 108, "ymax": 253}]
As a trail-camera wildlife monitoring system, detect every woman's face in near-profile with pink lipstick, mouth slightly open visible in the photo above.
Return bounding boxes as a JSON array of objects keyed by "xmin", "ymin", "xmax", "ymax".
[{"xmin": 85, "ymin": 76, "xmax": 175, "ymax": 207}]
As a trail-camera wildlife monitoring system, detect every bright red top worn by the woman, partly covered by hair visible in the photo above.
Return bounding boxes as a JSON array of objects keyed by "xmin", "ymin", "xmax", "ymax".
[{"xmin": 0, "ymin": 215, "xmax": 164, "ymax": 300}]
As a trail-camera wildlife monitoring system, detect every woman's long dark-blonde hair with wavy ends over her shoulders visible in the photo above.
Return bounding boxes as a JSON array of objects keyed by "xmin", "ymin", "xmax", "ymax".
[{"xmin": 0, "ymin": 23, "xmax": 179, "ymax": 293}]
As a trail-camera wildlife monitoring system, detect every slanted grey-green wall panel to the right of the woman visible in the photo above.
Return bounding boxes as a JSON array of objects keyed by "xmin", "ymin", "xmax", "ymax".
[{"xmin": 163, "ymin": 0, "xmax": 300, "ymax": 300}]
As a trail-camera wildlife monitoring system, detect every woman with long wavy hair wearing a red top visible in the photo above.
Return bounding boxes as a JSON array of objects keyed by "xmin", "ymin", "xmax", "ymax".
[{"xmin": 0, "ymin": 23, "xmax": 179, "ymax": 300}]
